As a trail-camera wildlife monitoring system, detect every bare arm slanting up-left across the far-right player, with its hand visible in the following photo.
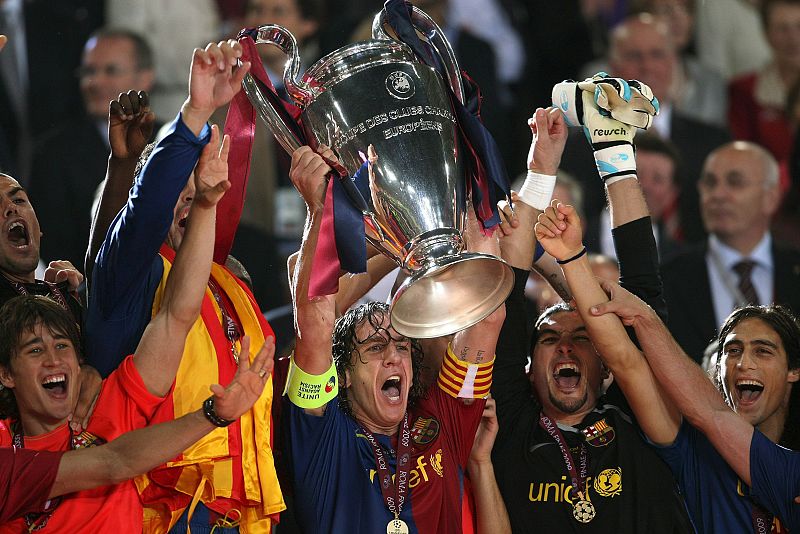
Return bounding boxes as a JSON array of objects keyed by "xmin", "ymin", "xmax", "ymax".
[{"xmin": 591, "ymin": 288, "xmax": 753, "ymax": 486}]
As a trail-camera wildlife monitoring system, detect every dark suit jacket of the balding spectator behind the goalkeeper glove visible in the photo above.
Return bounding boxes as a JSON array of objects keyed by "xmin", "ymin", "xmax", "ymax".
[{"xmin": 561, "ymin": 109, "xmax": 731, "ymax": 250}]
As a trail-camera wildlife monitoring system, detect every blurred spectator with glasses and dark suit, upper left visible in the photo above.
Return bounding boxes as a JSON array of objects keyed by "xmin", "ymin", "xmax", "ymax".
[{"xmin": 29, "ymin": 29, "xmax": 154, "ymax": 272}]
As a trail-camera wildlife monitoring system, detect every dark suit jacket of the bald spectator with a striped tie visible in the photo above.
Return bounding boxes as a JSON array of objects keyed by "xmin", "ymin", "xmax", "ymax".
[{"xmin": 661, "ymin": 242, "xmax": 800, "ymax": 362}]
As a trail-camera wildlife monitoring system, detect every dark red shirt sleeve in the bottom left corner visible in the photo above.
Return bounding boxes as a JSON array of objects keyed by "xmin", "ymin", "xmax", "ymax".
[{"xmin": 0, "ymin": 447, "xmax": 64, "ymax": 525}]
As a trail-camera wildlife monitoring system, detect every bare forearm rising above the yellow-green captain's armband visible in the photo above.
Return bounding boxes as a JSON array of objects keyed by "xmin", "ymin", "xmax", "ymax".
[{"xmin": 292, "ymin": 207, "xmax": 336, "ymax": 375}]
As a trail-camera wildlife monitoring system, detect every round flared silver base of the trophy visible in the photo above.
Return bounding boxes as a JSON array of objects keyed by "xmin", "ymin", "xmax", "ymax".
[{"xmin": 391, "ymin": 252, "xmax": 514, "ymax": 339}]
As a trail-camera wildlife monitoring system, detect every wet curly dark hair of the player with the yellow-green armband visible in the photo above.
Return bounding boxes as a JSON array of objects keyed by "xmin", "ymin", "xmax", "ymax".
[{"xmin": 331, "ymin": 302, "xmax": 425, "ymax": 416}]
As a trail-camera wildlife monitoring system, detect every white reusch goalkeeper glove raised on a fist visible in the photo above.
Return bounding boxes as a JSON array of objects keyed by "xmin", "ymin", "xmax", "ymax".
[{"xmin": 553, "ymin": 73, "xmax": 659, "ymax": 185}]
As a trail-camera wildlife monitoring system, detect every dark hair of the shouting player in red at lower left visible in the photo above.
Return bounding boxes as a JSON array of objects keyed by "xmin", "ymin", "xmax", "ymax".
[{"xmin": 0, "ymin": 295, "xmax": 81, "ymax": 419}]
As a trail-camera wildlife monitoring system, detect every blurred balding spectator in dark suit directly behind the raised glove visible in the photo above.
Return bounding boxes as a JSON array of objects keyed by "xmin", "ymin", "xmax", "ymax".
[{"xmin": 562, "ymin": 14, "xmax": 730, "ymax": 248}]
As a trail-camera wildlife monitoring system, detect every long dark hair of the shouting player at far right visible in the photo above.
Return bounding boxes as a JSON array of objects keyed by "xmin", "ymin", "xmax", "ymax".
[{"xmin": 714, "ymin": 304, "xmax": 800, "ymax": 450}]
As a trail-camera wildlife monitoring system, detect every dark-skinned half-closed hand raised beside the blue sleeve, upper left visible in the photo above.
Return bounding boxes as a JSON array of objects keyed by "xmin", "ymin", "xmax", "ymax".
[{"xmin": 108, "ymin": 90, "xmax": 156, "ymax": 159}]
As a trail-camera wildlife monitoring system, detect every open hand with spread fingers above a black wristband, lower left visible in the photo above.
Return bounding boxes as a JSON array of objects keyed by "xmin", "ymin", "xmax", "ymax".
[{"xmin": 211, "ymin": 336, "xmax": 275, "ymax": 421}]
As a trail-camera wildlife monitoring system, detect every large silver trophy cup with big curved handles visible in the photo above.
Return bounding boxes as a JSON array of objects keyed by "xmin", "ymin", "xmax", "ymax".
[{"xmin": 243, "ymin": 8, "xmax": 514, "ymax": 338}]
